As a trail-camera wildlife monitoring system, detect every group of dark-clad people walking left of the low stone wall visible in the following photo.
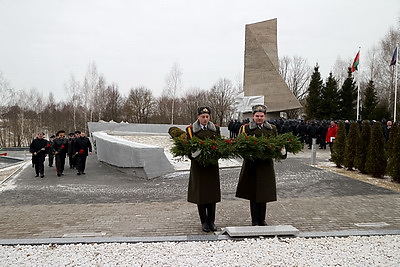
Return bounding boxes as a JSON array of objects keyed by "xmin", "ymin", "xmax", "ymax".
[{"xmin": 29, "ymin": 130, "xmax": 92, "ymax": 178}]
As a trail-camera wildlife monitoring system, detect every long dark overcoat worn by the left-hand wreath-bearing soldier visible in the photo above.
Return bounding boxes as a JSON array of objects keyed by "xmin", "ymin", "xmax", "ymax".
[{"xmin": 186, "ymin": 121, "xmax": 221, "ymax": 204}]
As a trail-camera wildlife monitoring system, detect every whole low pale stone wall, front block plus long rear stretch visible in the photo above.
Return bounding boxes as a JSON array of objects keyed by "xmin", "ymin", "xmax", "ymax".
[{"xmin": 88, "ymin": 122, "xmax": 229, "ymax": 179}]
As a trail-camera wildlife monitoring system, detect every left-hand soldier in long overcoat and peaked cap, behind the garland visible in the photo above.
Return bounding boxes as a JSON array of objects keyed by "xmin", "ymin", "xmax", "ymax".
[{"xmin": 186, "ymin": 107, "xmax": 221, "ymax": 232}]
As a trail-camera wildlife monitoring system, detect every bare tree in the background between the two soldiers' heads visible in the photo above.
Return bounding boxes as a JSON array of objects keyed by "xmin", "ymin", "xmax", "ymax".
[{"xmin": 208, "ymin": 79, "xmax": 237, "ymax": 126}]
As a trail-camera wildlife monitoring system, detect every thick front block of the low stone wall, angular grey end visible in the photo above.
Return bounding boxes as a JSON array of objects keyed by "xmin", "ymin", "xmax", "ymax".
[{"xmin": 92, "ymin": 132, "xmax": 174, "ymax": 179}]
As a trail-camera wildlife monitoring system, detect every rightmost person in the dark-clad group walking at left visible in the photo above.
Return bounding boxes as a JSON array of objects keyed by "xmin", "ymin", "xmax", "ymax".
[{"xmin": 74, "ymin": 131, "xmax": 92, "ymax": 175}]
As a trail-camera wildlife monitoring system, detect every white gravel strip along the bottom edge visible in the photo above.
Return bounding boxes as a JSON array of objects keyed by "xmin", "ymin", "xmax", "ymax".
[{"xmin": 0, "ymin": 236, "xmax": 400, "ymax": 266}]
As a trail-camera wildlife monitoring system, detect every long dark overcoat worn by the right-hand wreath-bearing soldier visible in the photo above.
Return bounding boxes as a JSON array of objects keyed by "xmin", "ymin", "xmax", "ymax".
[{"xmin": 236, "ymin": 122, "xmax": 277, "ymax": 203}]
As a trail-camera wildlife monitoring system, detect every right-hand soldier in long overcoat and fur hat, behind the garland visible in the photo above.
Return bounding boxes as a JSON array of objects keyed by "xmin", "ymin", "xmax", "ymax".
[{"xmin": 236, "ymin": 105, "xmax": 286, "ymax": 226}]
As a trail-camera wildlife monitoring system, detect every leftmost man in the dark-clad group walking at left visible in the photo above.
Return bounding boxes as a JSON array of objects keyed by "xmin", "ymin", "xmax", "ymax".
[{"xmin": 29, "ymin": 133, "xmax": 48, "ymax": 178}]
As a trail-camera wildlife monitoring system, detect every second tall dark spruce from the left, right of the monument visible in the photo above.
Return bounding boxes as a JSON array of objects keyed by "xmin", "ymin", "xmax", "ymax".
[{"xmin": 321, "ymin": 72, "xmax": 339, "ymax": 119}]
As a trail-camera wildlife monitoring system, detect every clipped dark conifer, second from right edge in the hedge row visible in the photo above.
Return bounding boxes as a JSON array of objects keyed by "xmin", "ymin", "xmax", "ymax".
[{"xmin": 365, "ymin": 122, "xmax": 387, "ymax": 178}]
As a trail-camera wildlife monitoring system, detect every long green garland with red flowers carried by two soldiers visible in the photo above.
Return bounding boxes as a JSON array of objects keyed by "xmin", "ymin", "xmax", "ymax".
[{"xmin": 171, "ymin": 133, "xmax": 303, "ymax": 166}]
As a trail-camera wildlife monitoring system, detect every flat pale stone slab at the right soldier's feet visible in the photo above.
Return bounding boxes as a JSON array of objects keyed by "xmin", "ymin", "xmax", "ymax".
[{"xmin": 221, "ymin": 225, "xmax": 300, "ymax": 237}]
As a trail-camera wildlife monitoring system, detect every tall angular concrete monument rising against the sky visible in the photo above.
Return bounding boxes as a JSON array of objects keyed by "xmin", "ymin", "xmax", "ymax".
[{"xmin": 243, "ymin": 19, "xmax": 302, "ymax": 118}]
